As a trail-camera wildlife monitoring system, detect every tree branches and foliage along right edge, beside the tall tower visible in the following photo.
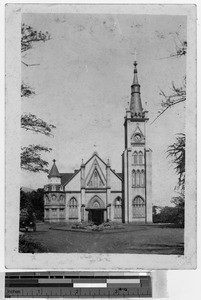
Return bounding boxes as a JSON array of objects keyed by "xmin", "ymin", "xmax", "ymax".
[{"xmin": 152, "ymin": 34, "xmax": 187, "ymax": 227}]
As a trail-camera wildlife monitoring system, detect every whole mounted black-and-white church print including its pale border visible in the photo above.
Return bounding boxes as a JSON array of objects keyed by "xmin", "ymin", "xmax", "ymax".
[{"xmin": 6, "ymin": 4, "xmax": 196, "ymax": 268}]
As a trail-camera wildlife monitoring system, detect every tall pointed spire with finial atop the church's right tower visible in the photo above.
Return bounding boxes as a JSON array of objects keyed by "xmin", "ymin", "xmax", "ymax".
[{"xmin": 130, "ymin": 60, "xmax": 143, "ymax": 118}]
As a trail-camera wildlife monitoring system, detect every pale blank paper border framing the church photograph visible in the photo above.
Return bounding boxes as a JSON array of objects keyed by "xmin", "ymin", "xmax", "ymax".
[{"xmin": 5, "ymin": 4, "xmax": 197, "ymax": 271}]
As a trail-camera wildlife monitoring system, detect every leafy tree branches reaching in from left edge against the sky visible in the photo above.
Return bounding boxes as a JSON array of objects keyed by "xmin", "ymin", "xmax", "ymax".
[{"xmin": 21, "ymin": 24, "xmax": 56, "ymax": 172}]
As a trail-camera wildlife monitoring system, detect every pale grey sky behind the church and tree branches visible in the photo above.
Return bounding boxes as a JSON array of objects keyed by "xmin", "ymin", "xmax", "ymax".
[{"xmin": 21, "ymin": 13, "xmax": 186, "ymax": 205}]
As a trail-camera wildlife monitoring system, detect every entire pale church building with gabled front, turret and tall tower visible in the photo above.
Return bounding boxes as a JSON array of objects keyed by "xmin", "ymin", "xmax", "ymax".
[{"xmin": 44, "ymin": 62, "xmax": 152, "ymax": 224}]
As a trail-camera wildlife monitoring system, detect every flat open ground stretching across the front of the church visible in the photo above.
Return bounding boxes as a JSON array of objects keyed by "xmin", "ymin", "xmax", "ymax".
[{"xmin": 19, "ymin": 223, "xmax": 184, "ymax": 255}]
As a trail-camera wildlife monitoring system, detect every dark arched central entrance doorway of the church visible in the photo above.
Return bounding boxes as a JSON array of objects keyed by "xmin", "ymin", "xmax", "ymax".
[{"xmin": 86, "ymin": 196, "xmax": 106, "ymax": 225}]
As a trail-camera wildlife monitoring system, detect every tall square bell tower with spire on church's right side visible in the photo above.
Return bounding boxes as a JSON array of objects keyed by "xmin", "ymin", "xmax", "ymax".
[{"xmin": 123, "ymin": 61, "xmax": 152, "ymax": 223}]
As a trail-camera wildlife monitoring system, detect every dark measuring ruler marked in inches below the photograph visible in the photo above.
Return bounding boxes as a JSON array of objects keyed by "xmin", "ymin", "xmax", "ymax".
[{"xmin": 5, "ymin": 271, "xmax": 152, "ymax": 298}]
